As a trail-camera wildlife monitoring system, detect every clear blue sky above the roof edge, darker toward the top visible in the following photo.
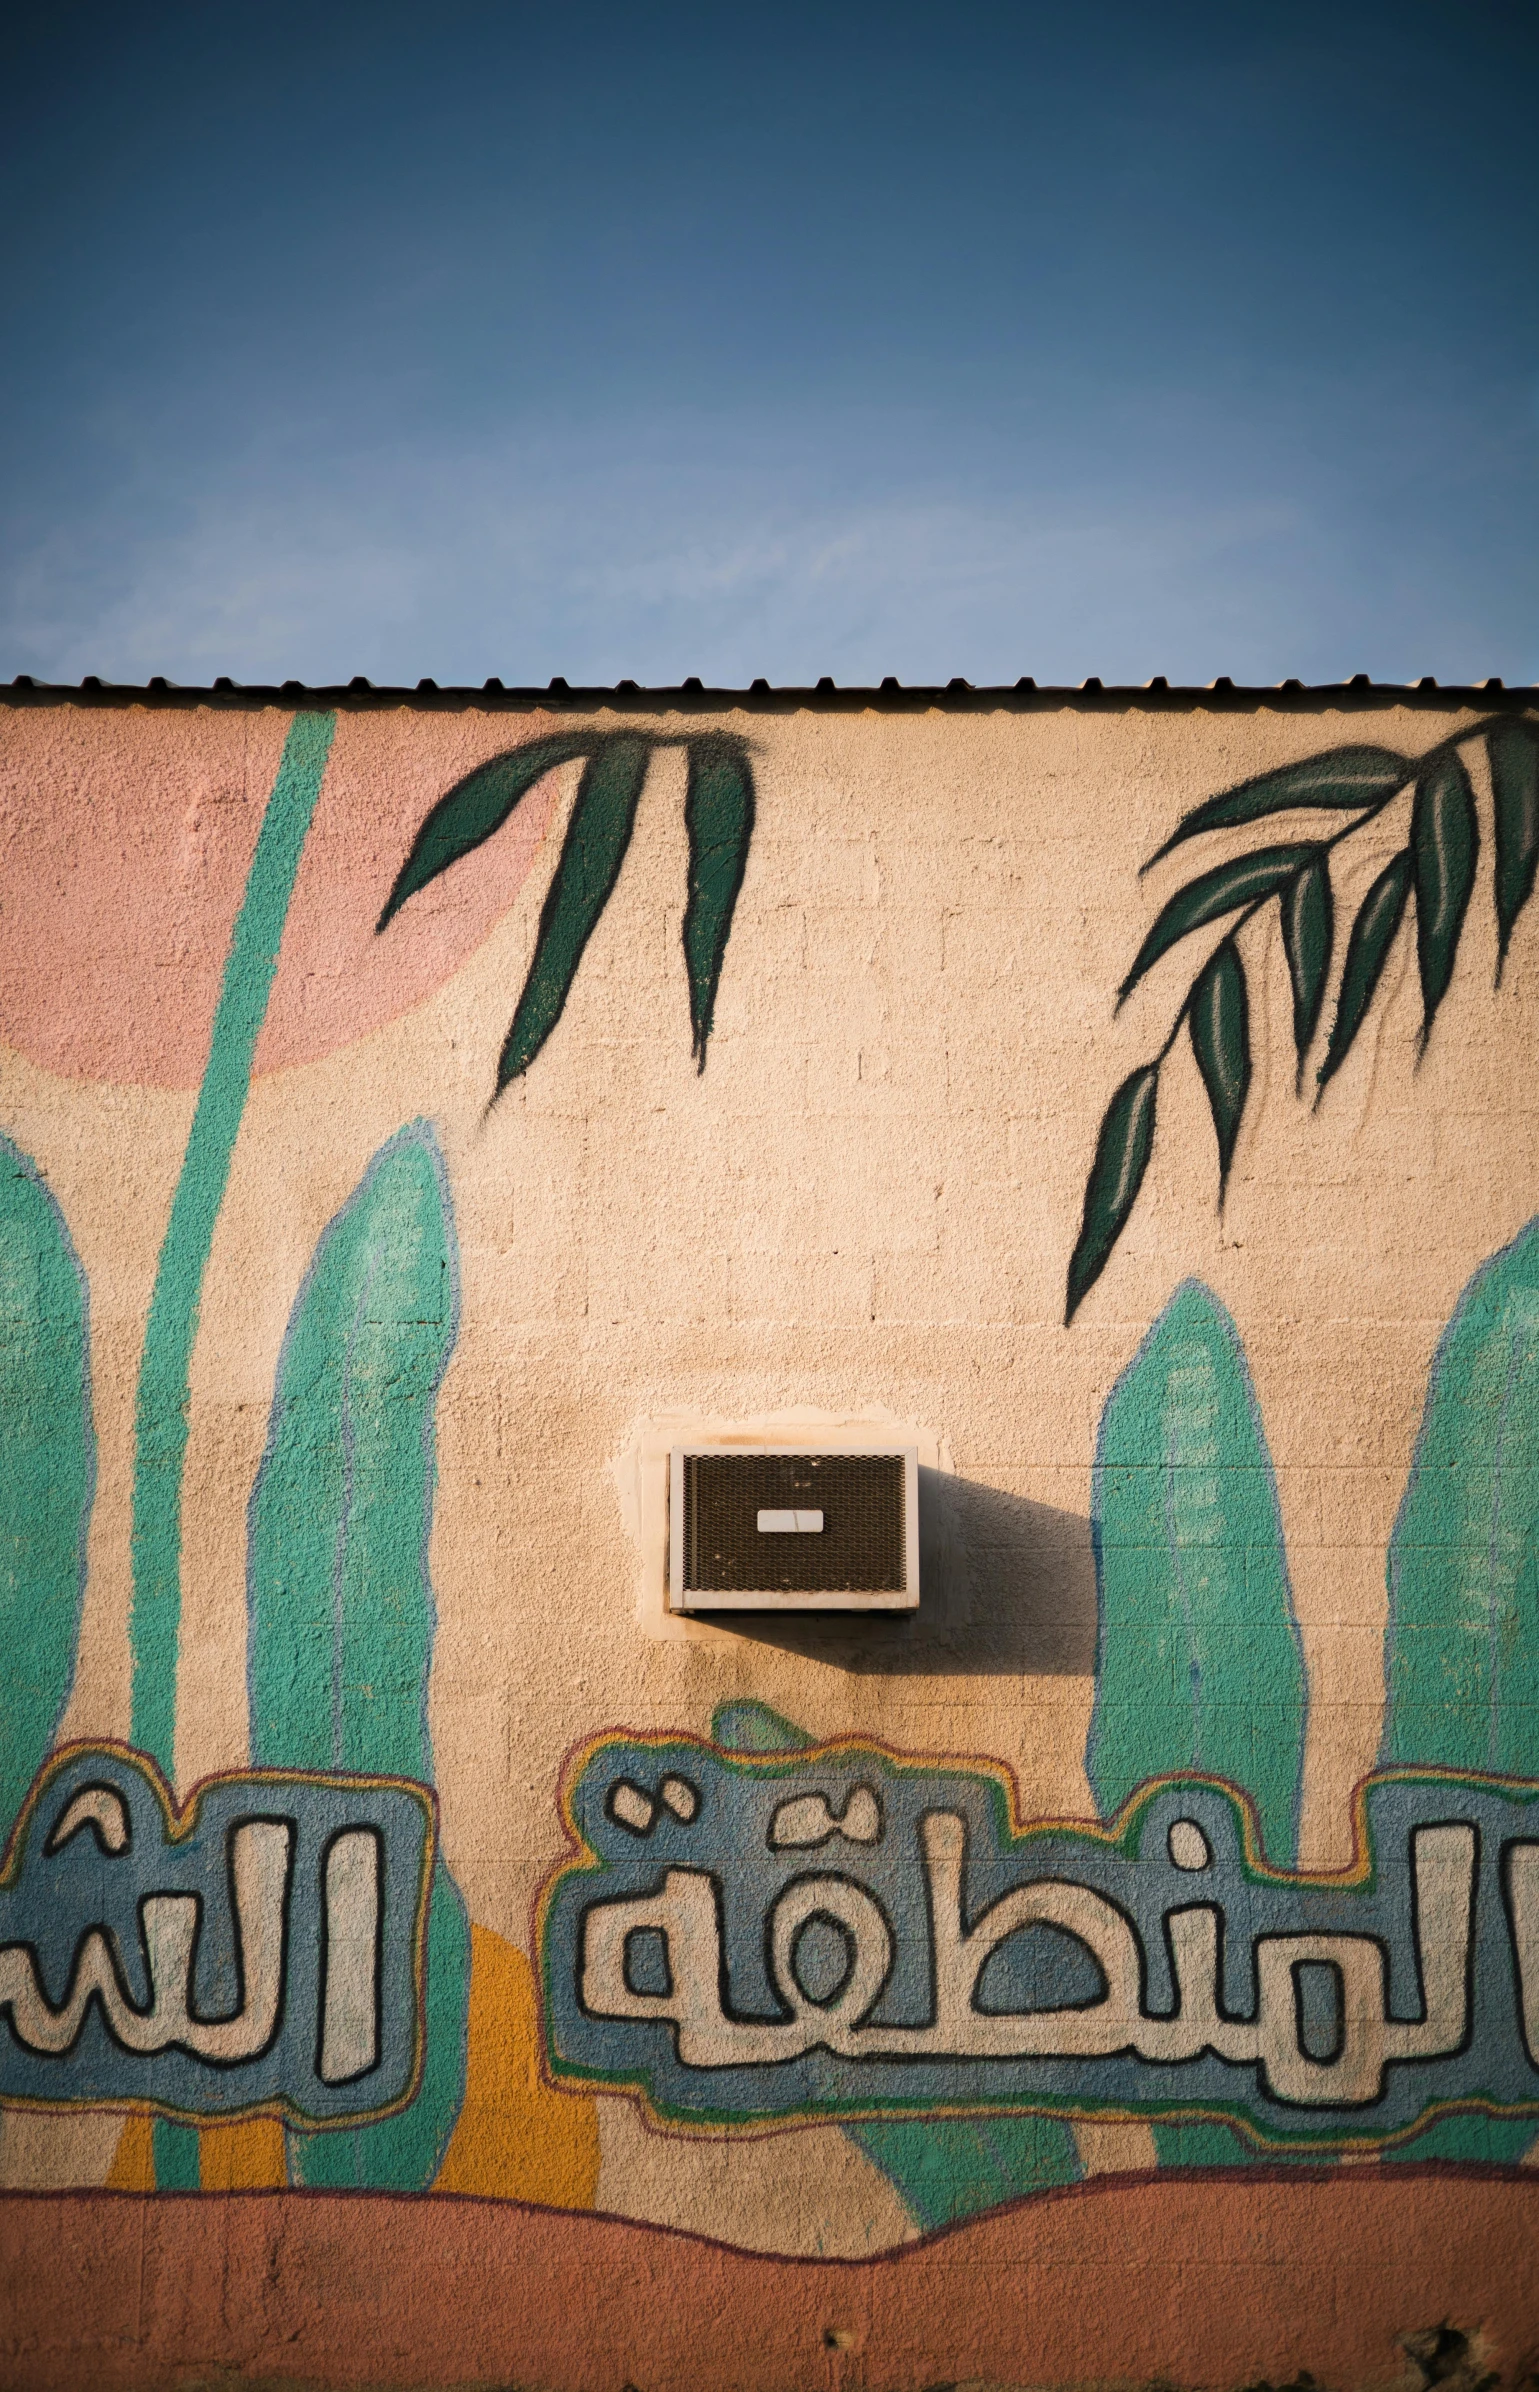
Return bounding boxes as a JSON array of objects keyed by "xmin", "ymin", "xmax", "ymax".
[{"xmin": 0, "ymin": 0, "xmax": 1539, "ymax": 684}]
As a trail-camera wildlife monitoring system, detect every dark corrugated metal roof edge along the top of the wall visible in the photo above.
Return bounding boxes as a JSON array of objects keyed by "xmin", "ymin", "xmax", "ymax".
[{"xmin": 0, "ymin": 672, "xmax": 1539, "ymax": 715}]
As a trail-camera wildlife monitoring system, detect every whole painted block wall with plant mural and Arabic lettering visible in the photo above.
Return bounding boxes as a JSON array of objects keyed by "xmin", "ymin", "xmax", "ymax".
[{"xmin": 0, "ymin": 694, "xmax": 1539, "ymax": 2387}]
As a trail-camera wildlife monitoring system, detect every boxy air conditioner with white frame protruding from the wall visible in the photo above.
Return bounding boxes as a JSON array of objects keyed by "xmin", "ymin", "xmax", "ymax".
[{"xmin": 668, "ymin": 1440, "xmax": 919, "ymax": 1612}]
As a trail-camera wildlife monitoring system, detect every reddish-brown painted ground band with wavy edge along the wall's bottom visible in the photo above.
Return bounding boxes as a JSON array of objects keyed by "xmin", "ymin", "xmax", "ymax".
[{"xmin": 0, "ymin": 2167, "xmax": 1539, "ymax": 2392}]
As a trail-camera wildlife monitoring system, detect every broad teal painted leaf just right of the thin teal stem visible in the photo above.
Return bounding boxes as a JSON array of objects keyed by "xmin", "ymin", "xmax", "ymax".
[{"xmin": 247, "ymin": 1122, "xmax": 469, "ymax": 2191}]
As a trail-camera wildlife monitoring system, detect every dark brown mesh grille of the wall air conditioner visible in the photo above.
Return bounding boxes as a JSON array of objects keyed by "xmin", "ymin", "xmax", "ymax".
[{"xmin": 685, "ymin": 1452, "xmax": 905, "ymax": 1595}]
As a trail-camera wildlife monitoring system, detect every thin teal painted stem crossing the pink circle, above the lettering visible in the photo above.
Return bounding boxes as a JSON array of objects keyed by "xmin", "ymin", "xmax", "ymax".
[{"xmin": 129, "ymin": 713, "xmax": 337, "ymax": 1775}]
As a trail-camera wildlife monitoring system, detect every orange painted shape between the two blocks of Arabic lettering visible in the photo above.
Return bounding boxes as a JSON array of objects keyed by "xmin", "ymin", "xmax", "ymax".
[{"xmin": 433, "ymin": 1926, "xmax": 598, "ymax": 2210}]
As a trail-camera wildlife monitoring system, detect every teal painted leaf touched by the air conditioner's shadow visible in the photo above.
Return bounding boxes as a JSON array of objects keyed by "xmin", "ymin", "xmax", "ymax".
[{"xmin": 1084, "ymin": 1280, "xmax": 1307, "ymax": 1866}]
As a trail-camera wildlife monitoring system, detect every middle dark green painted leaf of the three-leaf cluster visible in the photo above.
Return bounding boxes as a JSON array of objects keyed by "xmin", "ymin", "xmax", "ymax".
[{"xmin": 498, "ymin": 732, "xmax": 653, "ymax": 1096}]
